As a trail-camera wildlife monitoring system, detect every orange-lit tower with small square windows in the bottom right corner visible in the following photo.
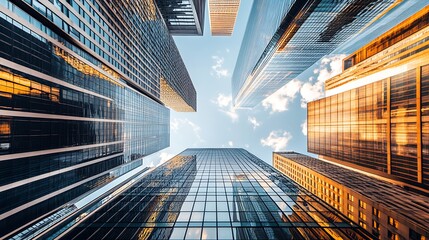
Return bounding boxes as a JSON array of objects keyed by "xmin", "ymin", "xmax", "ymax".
[{"xmin": 273, "ymin": 152, "xmax": 429, "ymax": 240}]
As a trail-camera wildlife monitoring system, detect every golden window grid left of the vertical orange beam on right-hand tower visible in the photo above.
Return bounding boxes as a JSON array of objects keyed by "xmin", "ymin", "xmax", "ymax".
[{"xmin": 308, "ymin": 80, "xmax": 388, "ymax": 172}]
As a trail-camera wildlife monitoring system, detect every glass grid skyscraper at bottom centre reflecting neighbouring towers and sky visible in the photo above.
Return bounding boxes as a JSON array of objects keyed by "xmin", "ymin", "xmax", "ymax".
[{"xmin": 46, "ymin": 148, "xmax": 371, "ymax": 239}]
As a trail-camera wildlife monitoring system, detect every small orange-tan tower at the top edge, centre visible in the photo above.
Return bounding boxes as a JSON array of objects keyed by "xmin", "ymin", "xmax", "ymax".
[{"xmin": 209, "ymin": 0, "xmax": 240, "ymax": 36}]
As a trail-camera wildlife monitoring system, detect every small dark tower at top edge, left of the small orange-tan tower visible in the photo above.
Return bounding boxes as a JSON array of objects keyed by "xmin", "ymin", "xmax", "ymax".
[{"xmin": 156, "ymin": 0, "xmax": 206, "ymax": 36}]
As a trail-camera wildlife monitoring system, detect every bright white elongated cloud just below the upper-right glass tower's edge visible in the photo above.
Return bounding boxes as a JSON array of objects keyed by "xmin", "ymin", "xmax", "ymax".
[{"xmin": 262, "ymin": 79, "xmax": 302, "ymax": 113}]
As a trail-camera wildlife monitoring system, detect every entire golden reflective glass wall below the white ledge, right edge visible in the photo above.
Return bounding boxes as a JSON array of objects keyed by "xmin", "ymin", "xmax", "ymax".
[{"xmin": 308, "ymin": 65, "xmax": 429, "ymax": 189}]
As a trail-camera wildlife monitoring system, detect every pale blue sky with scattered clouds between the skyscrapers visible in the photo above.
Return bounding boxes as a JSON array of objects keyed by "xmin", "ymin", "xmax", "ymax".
[{"xmin": 145, "ymin": 0, "xmax": 428, "ymax": 165}]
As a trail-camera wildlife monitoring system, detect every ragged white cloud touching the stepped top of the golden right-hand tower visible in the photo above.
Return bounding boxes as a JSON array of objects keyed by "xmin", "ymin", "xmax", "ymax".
[{"xmin": 300, "ymin": 54, "xmax": 346, "ymax": 108}]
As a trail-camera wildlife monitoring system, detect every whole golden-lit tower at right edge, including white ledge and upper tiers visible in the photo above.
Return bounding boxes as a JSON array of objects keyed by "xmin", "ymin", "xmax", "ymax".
[{"xmin": 308, "ymin": 6, "xmax": 429, "ymax": 193}]
